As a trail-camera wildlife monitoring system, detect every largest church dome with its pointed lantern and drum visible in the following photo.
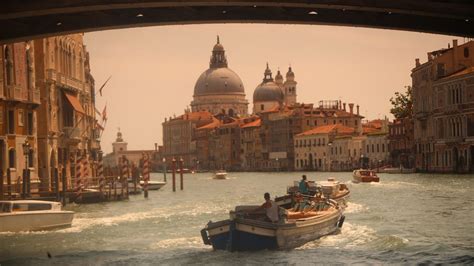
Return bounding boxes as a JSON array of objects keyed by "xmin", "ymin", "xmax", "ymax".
[{"xmin": 191, "ymin": 36, "xmax": 248, "ymax": 116}]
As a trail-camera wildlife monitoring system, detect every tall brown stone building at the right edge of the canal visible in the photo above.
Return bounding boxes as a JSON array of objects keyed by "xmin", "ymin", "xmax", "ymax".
[{"xmin": 411, "ymin": 40, "xmax": 474, "ymax": 172}]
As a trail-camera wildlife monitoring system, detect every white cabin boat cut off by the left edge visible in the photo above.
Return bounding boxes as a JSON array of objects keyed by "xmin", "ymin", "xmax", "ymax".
[{"xmin": 0, "ymin": 200, "xmax": 74, "ymax": 232}]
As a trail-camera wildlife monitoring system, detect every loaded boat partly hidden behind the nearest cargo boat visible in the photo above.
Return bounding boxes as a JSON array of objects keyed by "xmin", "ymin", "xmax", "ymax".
[{"xmin": 275, "ymin": 177, "xmax": 350, "ymax": 208}]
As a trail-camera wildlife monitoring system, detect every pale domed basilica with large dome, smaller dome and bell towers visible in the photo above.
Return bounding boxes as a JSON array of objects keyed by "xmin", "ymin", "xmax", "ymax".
[{"xmin": 191, "ymin": 36, "xmax": 296, "ymax": 116}]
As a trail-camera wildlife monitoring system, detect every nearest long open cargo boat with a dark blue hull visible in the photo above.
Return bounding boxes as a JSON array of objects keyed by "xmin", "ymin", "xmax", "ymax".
[{"xmin": 201, "ymin": 200, "xmax": 345, "ymax": 251}]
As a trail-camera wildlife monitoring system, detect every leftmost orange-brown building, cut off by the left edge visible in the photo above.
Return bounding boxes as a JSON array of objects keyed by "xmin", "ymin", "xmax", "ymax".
[{"xmin": 0, "ymin": 41, "xmax": 40, "ymax": 192}]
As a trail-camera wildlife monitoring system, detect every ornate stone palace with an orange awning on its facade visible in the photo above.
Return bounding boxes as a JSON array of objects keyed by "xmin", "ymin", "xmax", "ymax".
[{"xmin": 34, "ymin": 34, "xmax": 100, "ymax": 190}]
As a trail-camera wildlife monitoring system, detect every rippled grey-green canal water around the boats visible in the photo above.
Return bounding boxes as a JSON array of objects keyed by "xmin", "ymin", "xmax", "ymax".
[{"xmin": 0, "ymin": 173, "xmax": 474, "ymax": 265}]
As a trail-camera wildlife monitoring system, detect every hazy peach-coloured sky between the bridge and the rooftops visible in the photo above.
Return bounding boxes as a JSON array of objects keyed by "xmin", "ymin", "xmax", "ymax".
[{"xmin": 85, "ymin": 24, "xmax": 463, "ymax": 155}]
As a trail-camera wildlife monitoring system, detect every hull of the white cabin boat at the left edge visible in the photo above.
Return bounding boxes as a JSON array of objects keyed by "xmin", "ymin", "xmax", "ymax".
[{"xmin": 0, "ymin": 211, "xmax": 74, "ymax": 232}]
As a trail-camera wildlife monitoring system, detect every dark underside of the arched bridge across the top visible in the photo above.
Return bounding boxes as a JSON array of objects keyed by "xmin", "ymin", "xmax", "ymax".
[{"xmin": 0, "ymin": 0, "xmax": 474, "ymax": 42}]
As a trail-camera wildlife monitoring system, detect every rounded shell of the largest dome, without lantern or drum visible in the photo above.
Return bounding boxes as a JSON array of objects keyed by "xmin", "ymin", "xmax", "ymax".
[{"xmin": 194, "ymin": 67, "xmax": 245, "ymax": 96}]
